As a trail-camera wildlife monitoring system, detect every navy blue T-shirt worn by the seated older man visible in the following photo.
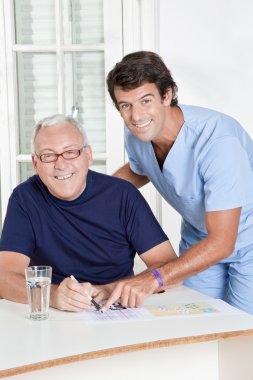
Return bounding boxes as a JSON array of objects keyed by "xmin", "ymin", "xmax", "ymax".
[{"xmin": 0, "ymin": 170, "xmax": 168, "ymax": 284}]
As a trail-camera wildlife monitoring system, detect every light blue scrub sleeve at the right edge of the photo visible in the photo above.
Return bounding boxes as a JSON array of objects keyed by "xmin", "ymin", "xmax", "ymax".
[{"xmin": 200, "ymin": 137, "xmax": 253, "ymax": 211}]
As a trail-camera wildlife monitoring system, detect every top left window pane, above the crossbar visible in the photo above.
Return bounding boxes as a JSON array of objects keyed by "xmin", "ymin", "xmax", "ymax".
[{"xmin": 14, "ymin": 0, "xmax": 55, "ymax": 44}]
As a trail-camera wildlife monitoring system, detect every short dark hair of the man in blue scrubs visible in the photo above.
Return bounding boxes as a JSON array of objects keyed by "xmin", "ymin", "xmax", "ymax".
[{"xmin": 107, "ymin": 51, "xmax": 178, "ymax": 108}]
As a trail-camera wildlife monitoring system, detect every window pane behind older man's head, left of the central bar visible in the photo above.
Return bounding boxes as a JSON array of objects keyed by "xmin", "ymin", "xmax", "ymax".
[{"xmin": 17, "ymin": 53, "xmax": 57, "ymax": 154}]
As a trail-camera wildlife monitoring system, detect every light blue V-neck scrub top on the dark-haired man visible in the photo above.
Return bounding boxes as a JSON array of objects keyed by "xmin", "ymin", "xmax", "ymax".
[{"xmin": 125, "ymin": 105, "xmax": 253, "ymax": 249}]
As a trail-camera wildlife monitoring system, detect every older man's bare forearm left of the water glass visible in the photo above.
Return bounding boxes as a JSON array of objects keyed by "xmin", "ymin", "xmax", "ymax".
[{"xmin": 0, "ymin": 272, "xmax": 27, "ymax": 303}]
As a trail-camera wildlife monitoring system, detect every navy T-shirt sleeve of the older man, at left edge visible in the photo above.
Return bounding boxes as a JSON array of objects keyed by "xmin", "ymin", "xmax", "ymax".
[{"xmin": 0, "ymin": 194, "xmax": 35, "ymax": 257}]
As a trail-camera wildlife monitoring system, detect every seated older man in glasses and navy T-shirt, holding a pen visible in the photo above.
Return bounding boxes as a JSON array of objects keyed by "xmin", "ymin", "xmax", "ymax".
[{"xmin": 0, "ymin": 115, "xmax": 176, "ymax": 311}]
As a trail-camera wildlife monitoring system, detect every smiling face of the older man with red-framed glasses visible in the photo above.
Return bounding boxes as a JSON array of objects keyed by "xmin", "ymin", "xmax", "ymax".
[{"xmin": 32, "ymin": 122, "xmax": 92, "ymax": 201}]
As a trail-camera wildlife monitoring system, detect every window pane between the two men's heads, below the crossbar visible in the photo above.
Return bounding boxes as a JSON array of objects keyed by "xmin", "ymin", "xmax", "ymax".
[{"xmin": 64, "ymin": 52, "xmax": 106, "ymax": 154}]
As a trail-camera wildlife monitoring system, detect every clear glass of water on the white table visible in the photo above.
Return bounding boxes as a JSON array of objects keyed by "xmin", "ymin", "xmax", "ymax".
[{"xmin": 25, "ymin": 265, "xmax": 52, "ymax": 321}]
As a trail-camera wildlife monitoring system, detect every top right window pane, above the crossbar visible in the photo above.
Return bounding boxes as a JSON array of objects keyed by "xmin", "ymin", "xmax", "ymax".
[{"xmin": 62, "ymin": 0, "xmax": 104, "ymax": 45}]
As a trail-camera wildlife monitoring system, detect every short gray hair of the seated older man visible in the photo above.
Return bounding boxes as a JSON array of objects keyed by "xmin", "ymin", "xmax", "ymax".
[{"xmin": 31, "ymin": 114, "xmax": 88, "ymax": 153}]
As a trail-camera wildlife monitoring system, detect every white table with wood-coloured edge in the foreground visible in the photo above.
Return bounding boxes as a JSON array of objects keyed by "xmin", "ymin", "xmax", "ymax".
[{"xmin": 0, "ymin": 286, "xmax": 253, "ymax": 380}]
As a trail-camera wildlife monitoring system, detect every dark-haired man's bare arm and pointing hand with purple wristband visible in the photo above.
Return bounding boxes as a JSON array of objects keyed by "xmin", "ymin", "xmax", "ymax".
[{"xmin": 104, "ymin": 208, "xmax": 240, "ymax": 310}]
